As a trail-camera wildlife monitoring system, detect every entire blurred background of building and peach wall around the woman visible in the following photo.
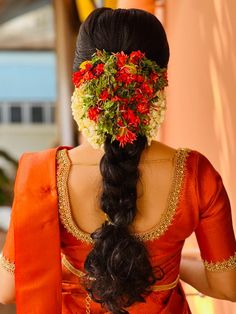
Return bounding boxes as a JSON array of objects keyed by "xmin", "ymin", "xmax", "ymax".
[{"xmin": 0, "ymin": 0, "xmax": 236, "ymax": 314}]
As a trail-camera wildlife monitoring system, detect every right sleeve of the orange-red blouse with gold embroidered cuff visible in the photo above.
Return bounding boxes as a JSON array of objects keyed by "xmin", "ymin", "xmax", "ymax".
[{"xmin": 195, "ymin": 154, "xmax": 236, "ymax": 271}]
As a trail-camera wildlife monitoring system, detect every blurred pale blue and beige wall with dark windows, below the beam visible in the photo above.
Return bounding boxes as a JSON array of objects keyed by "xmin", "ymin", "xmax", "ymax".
[{"xmin": 0, "ymin": 51, "xmax": 56, "ymax": 158}]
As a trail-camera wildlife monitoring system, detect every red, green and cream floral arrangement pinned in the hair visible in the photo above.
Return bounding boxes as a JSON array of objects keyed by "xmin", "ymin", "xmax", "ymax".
[{"xmin": 71, "ymin": 50, "xmax": 168, "ymax": 148}]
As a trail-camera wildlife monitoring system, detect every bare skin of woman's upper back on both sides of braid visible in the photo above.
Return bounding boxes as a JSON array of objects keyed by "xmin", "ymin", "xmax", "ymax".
[{"xmin": 68, "ymin": 142, "xmax": 176, "ymax": 233}]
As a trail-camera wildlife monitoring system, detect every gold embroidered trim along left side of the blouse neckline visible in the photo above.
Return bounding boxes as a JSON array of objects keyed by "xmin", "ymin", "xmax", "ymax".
[{"xmin": 57, "ymin": 149, "xmax": 93, "ymax": 243}]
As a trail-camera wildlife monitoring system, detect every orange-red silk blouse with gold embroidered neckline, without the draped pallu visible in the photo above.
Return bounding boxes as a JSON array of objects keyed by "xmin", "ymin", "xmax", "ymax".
[{"xmin": 1, "ymin": 147, "xmax": 236, "ymax": 314}]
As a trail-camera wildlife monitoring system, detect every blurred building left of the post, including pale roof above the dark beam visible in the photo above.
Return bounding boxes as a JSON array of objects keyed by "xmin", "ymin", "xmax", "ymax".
[{"xmin": 0, "ymin": 4, "xmax": 57, "ymax": 158}]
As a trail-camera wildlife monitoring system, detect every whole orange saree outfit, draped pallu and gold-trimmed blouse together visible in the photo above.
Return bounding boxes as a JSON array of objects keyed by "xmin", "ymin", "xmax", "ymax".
[{"xmin": 1, "ymin": 147, "xmax": 236, "ymax": 314}]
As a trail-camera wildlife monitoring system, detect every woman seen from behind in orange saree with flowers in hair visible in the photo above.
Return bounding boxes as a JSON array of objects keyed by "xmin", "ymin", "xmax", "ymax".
[{"xmin": 0, "ymin": 8, "xmax": 236, "ymax": 314}]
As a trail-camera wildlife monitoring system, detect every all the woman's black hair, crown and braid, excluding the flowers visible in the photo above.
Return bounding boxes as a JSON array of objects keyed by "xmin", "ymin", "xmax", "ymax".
[{"xmin": 73, "ymin": 8, "xmax": 169, "ymax": 314}]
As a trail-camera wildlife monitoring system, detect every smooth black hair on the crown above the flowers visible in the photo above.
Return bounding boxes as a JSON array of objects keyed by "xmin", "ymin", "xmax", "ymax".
[{"xmin": 73, "ymin": 8, "xmax": 169, "ymax": 71}]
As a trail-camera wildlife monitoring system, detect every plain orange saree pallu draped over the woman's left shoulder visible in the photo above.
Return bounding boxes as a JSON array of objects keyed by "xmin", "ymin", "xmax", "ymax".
[{"xmin": 12, "ymin": 147, "xmax": 69, "ymax": 314}]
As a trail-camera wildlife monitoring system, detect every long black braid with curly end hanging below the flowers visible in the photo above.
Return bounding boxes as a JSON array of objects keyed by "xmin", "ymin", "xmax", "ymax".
[{"xmin": 85, "ymin": 137, "xmax": 160, "ymax": 314}]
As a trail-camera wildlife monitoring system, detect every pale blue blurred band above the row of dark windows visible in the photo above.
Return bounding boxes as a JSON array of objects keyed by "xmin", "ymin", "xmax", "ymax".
[{"xmin": 0, "ymin": 51, "xmax": 56, "ymax": 102}]
